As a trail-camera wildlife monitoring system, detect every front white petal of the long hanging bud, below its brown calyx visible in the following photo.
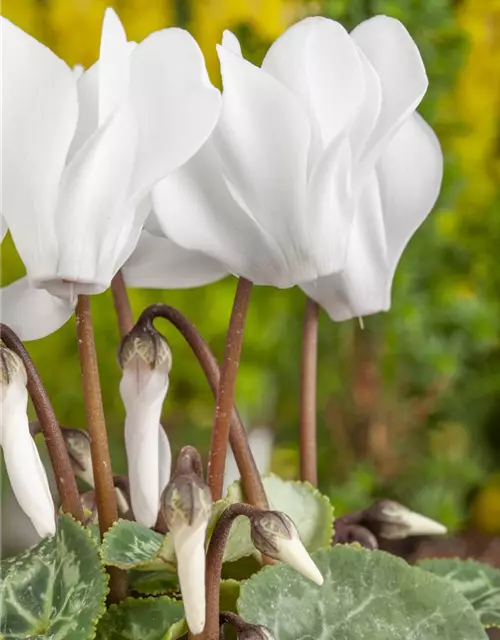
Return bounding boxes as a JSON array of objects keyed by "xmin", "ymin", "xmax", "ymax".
[{"xmin": 120, "ymin": 360, "xmax": 168, "ymax": 527}]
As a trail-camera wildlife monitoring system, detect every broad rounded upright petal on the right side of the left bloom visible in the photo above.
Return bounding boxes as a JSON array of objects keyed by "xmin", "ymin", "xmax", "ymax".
[{"xmin": 131, "ymin": 28, "xmax": 221, "ymax": 199}]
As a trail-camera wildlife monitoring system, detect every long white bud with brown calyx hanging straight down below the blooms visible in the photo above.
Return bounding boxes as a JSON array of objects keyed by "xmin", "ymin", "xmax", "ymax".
[{"xmin": 118, "ymin": 325, "xmax": 172, "ymax": 527}]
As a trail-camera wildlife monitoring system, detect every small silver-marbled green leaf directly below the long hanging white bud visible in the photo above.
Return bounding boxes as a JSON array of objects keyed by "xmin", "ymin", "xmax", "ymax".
[{"xmin": 101, "ymin": 520, "xmax": 175, "ymax": 570}]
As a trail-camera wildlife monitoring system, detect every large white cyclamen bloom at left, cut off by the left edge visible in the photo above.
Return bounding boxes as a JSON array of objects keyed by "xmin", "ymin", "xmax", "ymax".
[{"xmin": 0, "ymin": 9, "xmax": 220, "ymax": 340}]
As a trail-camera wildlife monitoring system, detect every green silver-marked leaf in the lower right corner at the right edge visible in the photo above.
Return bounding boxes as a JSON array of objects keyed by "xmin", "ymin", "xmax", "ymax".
[{"xmin": 418, "ymin": 558, "xmax": 500, "ymax": 627}]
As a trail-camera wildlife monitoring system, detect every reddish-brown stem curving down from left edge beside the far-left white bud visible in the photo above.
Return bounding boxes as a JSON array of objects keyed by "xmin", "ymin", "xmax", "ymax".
[{"xmin": 0, "ymin": 324, "xmax": 83, "ymax": 522}]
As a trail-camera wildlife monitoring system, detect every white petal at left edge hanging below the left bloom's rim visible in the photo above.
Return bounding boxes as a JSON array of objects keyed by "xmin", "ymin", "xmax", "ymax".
[{"xmin": 0, "ymin": 278, "xmax": 76, "ymax": 340}]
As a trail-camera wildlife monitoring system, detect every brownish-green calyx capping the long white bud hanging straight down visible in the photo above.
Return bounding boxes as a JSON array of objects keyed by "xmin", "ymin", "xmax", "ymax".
[{"xmin": 118, "ymin": 325, "xmax": 172, "ymax": 373}]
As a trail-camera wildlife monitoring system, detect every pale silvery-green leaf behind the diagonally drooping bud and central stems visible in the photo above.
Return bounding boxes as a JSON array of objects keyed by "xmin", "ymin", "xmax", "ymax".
[{"xmin": 224, "ymin": 474, "xmax": 333, "ymax": 562}]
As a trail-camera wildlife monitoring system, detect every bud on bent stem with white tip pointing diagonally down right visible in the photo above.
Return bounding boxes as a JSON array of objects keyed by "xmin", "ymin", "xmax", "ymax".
[{"xmin": 250, "ymin": 511, "xmax": 323, "ymax": 585}]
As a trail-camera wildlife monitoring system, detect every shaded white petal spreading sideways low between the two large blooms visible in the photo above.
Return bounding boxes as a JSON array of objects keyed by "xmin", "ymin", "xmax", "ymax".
[{"xmin": 122, "ymin": 231, "xmax": 228, "ymax": 289}]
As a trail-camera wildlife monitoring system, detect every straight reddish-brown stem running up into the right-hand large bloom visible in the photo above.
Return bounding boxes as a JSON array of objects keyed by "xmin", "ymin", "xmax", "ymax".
[{"xmin": 207, "ymin": 278, "xmax": 253, "ymax": 501}]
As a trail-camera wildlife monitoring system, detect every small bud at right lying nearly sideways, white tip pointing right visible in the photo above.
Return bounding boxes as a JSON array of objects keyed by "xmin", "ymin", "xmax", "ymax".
[{"xmin": 361, "ymin": 500, "xmax": 447, "ymax": 540}]
